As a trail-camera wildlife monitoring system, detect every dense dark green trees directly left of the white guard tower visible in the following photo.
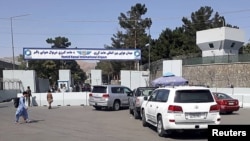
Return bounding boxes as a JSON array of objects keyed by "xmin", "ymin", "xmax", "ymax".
[{"xmin": 151, "ymin": 6, "xmax": 238, "ymax": 61}]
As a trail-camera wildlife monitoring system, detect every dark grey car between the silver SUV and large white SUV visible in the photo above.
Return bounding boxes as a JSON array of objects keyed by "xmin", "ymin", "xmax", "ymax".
[{"xmin": 129, "ymin": 87, "xmax": 156, "ymax": 119}]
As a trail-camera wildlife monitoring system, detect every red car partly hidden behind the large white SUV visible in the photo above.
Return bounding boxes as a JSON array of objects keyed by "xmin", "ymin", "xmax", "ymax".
[{"xmin": 213, "ymin": 92, "xmax": 240, "ymax": 114}]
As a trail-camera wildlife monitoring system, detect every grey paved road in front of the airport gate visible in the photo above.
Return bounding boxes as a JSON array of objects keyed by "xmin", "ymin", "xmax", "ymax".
[{"xmin": 0, "ymin": 102, "xmax": 250, "ymax": 141}]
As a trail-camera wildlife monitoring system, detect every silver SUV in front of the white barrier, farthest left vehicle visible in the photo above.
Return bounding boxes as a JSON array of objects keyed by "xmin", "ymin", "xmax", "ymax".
[{"xmin": 89, "ymin": 85, "xmax": 132, "ymax": 111}]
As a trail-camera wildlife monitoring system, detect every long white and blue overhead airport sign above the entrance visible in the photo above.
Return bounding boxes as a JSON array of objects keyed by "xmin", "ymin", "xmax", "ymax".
[{"xmin": 23, "ymin": 48, "xmax": 141, "ymax": 60}]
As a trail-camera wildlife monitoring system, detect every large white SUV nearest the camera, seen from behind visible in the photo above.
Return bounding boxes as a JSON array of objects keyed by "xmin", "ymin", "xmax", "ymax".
[{"xmin": 141, "ymin": 86, "xmax": 221, "ymax": 136}]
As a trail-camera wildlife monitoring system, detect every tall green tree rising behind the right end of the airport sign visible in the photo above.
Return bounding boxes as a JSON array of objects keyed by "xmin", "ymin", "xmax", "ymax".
[{"xmin": 97, "ymin": 3, "xmax": 152, "ymax": 80}]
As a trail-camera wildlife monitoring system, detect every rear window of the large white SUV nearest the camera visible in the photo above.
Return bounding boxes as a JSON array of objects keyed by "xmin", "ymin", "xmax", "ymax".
[{"xmin": 174, "ymin": 90, "xmax": 214, "ymax": 103}]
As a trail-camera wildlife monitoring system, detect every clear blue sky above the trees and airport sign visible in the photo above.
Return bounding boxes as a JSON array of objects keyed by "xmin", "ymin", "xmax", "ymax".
[{"xmin": 0, "ymin": 0, "xmax": 250, "ymax": 58}]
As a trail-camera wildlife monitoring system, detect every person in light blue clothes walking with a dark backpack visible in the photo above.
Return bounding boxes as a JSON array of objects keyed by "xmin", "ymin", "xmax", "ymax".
[{"xmin": 15, "ymin": 91, "xmax": 30, "ymax": 123}]
